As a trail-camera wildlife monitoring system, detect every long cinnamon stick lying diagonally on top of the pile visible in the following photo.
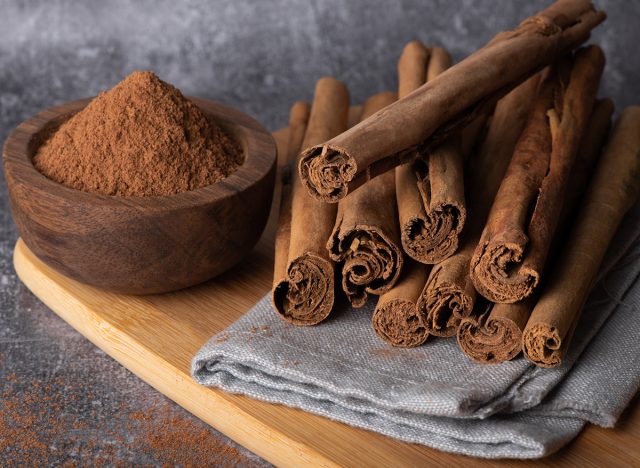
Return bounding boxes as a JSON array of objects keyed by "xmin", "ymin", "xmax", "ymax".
[{"xmin": 299, "ymin": 0, "xmax": 605, "ymax": 202}]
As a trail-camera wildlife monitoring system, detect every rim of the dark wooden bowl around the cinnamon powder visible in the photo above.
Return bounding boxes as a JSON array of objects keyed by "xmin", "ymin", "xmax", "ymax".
[{"xmin": 2, "ymin": 96, "xmax": 277, "ymax": 211}]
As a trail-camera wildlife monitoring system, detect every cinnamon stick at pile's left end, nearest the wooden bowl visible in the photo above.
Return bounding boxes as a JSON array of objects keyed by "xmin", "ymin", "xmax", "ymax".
[{"xmin": 273, "ymin": 77, "xmax": 349, "ymax": 325}]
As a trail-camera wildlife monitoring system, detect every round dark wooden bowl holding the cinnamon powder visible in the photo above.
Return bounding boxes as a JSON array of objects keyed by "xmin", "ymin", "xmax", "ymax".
[{"xmin": 3, "ymin": 98, "xmax": 276, "ymax": 294}]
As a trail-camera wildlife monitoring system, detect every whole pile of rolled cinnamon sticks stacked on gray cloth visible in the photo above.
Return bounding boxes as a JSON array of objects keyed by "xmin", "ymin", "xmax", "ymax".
[{"xmin": 273, "ymin": 0, "xmax": 640, "ymax": 366}]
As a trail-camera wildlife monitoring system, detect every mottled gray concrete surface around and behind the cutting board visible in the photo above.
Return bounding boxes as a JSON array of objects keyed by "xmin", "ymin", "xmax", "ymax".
[{"xmin": 0, "ymin": 0, "xmax": 640, "ymax": 465}]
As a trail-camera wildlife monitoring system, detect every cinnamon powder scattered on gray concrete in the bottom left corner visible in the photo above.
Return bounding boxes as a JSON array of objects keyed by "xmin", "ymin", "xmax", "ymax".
[{"xmin": 0, "ymin": 374, "xmax": 260, "ymax": 467}]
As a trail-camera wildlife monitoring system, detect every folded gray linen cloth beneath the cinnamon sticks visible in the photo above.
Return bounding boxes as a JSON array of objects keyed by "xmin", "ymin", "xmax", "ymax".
[{"xmin": 192, "ymin": 204, "xmax": 640, "ymax": 458}]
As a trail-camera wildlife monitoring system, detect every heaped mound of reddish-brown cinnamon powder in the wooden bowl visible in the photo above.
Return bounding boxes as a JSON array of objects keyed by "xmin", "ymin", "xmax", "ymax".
[{"xmin": 33, "ymin": 71, "xmax": 244, "ymax": 196}]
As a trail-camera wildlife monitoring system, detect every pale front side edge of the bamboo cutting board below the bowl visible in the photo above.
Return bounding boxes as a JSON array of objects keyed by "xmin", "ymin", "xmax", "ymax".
[{"xmin": 13, "ymin": 239, "xmax": 339, "ymax": 467}]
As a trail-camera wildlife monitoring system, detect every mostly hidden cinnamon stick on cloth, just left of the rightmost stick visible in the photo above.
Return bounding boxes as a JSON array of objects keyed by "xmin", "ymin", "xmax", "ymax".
[{"xmin": 457, "ymin": 99, "xmax": 613, "ymax": 364}]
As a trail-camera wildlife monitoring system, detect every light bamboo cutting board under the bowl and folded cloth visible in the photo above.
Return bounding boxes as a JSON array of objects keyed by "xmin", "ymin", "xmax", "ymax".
[{"xmin": 14, "ymin": 131, "xmax": 640, "ymax": 467}]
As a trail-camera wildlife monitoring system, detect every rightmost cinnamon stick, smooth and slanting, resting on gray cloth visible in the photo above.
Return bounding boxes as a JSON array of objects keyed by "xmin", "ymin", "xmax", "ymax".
[{"xmin": 522, "ymin": 107, "xmax": 640, "ymax": 367}]
